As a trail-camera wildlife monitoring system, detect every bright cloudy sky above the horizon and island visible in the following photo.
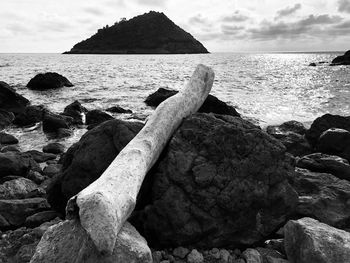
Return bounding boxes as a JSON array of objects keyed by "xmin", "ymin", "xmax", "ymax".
[{"xmin": 0, "ymin": 0, "xmax": 350, "ymax": 52}]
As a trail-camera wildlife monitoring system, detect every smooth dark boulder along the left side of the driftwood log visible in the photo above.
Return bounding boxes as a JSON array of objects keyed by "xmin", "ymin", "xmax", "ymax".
[{"xmin": 48, "ymin": 120, "xmax": 143, "ymax": 213}]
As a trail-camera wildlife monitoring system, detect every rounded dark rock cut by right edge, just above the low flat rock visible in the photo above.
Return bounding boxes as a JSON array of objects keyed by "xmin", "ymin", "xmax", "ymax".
[{"xmin": 316, "ymin": 128, "xmax": 350, "ymax": 161}]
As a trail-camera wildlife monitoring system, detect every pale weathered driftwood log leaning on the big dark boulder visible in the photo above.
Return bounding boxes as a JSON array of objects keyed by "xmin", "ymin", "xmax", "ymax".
[{"xmin": 66, "ymin": 65, "xmax": 214, "ymax": 254}]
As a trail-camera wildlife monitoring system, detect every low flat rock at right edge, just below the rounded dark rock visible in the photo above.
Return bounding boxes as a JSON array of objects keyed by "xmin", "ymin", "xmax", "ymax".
[{"xmin": 296, "ymin": 153, "xmax": 350, "ymax": 181}]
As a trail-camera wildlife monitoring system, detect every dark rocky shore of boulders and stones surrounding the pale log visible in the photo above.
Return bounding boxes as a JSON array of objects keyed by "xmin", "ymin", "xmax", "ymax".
[{"xmin": 0, "ymin": 73, "xmax": 350, "ymax": 263}]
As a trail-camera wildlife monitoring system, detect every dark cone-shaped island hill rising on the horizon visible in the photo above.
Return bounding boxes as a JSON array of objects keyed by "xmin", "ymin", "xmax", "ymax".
[{"xmin": 65, "ymin": 11, "xmax": 209, "ymax": 54}]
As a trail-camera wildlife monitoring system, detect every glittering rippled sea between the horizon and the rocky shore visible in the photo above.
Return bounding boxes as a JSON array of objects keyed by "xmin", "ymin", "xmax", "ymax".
[{"xmin": 0, "ymin": 52, "xmax": 350, "ymax": 150}]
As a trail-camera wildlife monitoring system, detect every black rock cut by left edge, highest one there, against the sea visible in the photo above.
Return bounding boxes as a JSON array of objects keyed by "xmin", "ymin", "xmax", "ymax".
[{"xmin": 0, "ymin": 81, "xmax": 29, "ymax": 114}]
